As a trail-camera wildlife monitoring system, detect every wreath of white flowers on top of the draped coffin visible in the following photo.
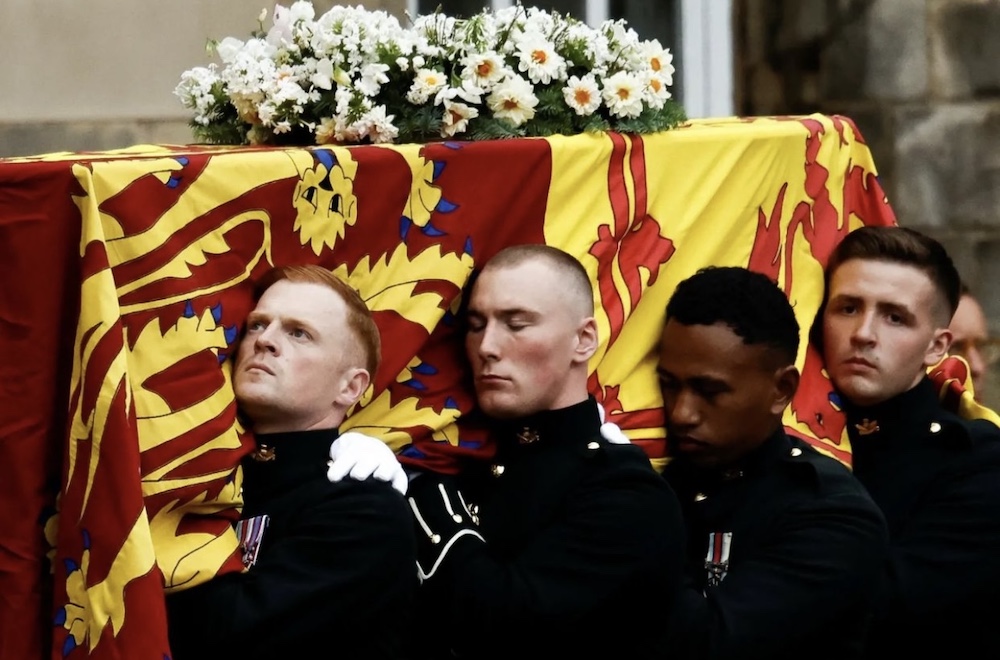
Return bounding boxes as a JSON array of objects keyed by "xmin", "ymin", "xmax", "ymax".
[{"xmin": 180, "ymin": 0, "xmax": 674, "ymax": 144}]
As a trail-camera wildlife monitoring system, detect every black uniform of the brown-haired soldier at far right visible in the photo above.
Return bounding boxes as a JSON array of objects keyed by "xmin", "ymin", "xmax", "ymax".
[{"xmin": 846, "ymin": 379, "xmax": 1000, "ymax": 658}]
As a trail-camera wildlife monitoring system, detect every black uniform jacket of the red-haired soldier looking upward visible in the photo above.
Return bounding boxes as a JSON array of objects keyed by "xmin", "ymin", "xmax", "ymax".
[{"xmin": 167, "ymin": 430, "xmax": 417, "ymax": 660}]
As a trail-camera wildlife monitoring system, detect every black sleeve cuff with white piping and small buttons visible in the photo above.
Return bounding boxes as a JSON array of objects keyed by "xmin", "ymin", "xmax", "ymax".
[{"xmin": 407, "ymin": 474, "xmax": 485, "ymax": 582}]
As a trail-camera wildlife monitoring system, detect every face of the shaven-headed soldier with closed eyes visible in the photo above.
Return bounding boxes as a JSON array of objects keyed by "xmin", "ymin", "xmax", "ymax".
[{"xmin": 465, "ymin": 261, "xmax": 596, "ymax": 419}]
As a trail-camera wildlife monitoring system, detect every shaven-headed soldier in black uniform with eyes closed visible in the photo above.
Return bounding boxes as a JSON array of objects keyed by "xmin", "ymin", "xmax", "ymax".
[{"xmin": 409, "ymin": 245, "xmax": 683, "ymax": 660}]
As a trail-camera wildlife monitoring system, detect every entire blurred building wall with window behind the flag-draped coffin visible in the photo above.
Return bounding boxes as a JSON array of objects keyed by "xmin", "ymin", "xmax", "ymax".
[{"xmin": 0, "ymin": 0, "xmax": 1000, "ymax": 408}]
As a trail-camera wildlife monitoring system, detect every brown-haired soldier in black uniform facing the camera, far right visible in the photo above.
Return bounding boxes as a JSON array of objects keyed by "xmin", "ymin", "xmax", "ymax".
[{"xmin": 815, "ymin": 227, "xmax": 1000, "ymax": 658}]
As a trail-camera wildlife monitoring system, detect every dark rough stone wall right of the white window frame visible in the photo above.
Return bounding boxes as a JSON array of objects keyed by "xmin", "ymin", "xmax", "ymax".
[{"xmin": 735, "ymin": 0, "xmax": 1000, "ymax": 408}]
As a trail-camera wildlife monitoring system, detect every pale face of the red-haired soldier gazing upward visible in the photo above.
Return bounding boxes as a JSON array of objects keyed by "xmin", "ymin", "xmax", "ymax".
[{"xmin": 233, "ymin": 280, "xmax": 367, "ymax": 433}]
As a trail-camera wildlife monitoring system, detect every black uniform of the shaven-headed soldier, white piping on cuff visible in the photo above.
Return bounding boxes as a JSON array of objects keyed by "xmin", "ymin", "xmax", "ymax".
[{"xmin": 409, "ymin": 399, "xmax": 683, "ymax": 660}]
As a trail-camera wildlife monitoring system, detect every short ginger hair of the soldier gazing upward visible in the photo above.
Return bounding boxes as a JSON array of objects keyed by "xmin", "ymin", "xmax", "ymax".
[{"xmin": 254, "ymin": 264, "xmax": 382, "ymax": 380}]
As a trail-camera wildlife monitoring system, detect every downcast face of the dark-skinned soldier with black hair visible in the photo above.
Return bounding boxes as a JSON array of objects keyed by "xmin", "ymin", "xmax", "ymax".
[{"xmin": 657, "ymin": 319, "xmax": 798, "ymax": 467}]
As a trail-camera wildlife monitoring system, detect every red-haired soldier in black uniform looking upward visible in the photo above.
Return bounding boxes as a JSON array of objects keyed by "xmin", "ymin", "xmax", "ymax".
[{"xmin": 167, "ymin": 266, "xmax": 418, "ymax": 660}]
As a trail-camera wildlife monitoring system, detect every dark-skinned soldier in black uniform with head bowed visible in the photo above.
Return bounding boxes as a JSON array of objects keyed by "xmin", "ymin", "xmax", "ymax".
[{"xmin": 657, "ymin": 267, "xmax": 887, "ymax": 660}]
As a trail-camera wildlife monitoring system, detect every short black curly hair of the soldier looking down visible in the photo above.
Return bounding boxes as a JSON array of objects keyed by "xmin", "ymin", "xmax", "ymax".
[{"xmin": 667, "ymin": 266, "xmax": 799, "ymax": 364}]
